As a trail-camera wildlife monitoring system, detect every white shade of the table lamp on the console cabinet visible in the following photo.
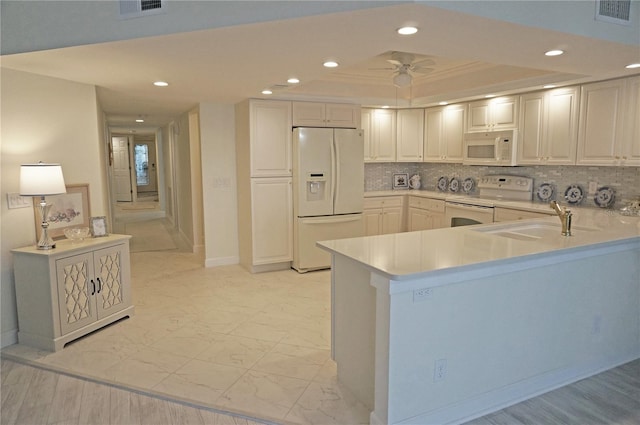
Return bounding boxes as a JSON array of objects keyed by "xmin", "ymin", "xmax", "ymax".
[{"xmin": 20, "ymin": 162, "xmax": 67, "ymax": 196}]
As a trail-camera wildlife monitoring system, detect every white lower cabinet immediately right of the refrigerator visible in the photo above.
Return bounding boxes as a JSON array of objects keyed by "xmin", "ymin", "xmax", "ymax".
[{"xmin": 363, "ymin": 196, "xmax": 404, "ymax": 236}]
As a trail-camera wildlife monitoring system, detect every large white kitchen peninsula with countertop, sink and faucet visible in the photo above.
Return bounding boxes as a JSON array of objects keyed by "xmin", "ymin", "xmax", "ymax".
[{"xmin": 318, "ymin": 208, "xmax": 640, "ymax": 424}]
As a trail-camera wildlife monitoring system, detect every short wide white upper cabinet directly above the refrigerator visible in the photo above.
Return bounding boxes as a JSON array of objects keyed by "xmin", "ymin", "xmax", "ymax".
[{"xmin": 293, "ymin": 102, "xmax": 361, "ymax": 128}]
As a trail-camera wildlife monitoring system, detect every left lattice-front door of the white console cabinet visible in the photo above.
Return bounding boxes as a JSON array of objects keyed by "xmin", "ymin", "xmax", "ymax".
[{"xmin": 56, "ymin": 253, "xmax": 98, "ymax": 334}]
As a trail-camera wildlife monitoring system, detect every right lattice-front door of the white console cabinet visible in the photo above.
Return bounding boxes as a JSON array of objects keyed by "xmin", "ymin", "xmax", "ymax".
[{"xmin": 94, "ymin": 245, "xmax": 127, "ymax": 318}]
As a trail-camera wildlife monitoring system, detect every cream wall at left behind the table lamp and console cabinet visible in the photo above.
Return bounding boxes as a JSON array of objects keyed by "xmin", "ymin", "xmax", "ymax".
[{"xmin": 0, "ymin": 69, "xmax": 108, "ymax": 346}]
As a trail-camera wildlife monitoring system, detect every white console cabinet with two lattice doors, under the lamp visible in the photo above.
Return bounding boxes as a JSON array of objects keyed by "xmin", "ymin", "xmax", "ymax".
[{"xmin": 11, "ymin": 235, "xmax": 134, "ymax": 351}]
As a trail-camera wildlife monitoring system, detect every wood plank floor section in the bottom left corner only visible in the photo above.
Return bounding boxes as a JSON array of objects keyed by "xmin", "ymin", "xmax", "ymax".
[{"xmin": 0, "ymin": 359, "xmax": 266, "ymax": 425}]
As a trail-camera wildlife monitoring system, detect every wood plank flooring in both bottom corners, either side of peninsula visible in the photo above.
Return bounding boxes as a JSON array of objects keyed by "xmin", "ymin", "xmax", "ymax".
[{"xmin": 0, "ymin": 359, "xmax": 640, "ymax": 425}]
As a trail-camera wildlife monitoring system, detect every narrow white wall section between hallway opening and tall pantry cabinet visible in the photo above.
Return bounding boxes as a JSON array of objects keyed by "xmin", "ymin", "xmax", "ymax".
[{"xmin": 200, "ymin": 103, "xmax": 239, "ymax": 267}]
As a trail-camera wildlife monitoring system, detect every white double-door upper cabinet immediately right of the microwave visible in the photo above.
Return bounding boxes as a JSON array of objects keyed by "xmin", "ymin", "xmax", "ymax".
[{"xmin": 518, "ymin": 87, "xmax": 579, "ymax": 165}]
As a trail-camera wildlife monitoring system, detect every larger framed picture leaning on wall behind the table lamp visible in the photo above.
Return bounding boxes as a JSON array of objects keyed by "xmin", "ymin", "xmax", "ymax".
[{"xmin": 33, "ymin": 183, "xmax": 91, "ymax": 240}]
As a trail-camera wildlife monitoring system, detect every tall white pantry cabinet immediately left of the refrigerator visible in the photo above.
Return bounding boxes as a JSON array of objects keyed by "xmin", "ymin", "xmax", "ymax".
[{"xmin": 236, "ymin": 99, "xmax": 293, "ymax": 273}]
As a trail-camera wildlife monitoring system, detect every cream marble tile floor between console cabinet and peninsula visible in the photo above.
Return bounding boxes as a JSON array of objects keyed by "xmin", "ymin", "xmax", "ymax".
[{"xmin": 2, "ymin": 234, "xmax": 369, "ymax": 424}]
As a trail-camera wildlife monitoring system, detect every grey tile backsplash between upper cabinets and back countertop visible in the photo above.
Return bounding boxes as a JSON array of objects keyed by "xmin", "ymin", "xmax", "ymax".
[{"xmin": 364, "ymin": 162, "xmax": 640, "ymax": 208}]
